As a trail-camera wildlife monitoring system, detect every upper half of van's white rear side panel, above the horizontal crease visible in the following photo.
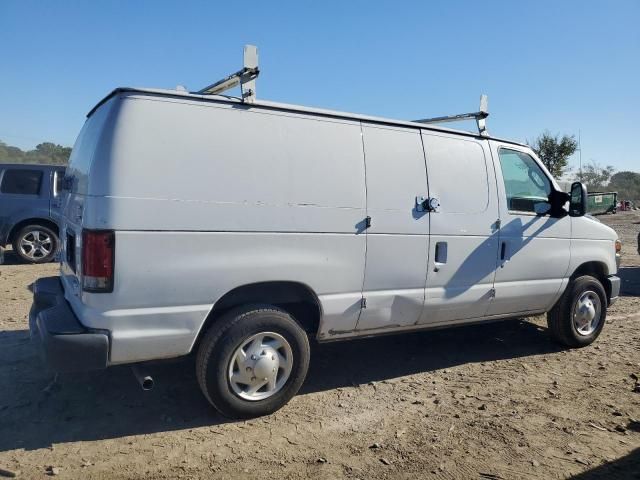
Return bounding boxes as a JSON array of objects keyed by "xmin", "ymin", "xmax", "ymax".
[{"xmin": 87, "ymin": 97, "xmax": 365, "ymax": 234}]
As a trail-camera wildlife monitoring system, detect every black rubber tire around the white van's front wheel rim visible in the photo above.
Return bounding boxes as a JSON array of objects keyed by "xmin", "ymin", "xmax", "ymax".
[{"xmin": 547, "ymin": 275, "xmax": 607, "ymax": 348}]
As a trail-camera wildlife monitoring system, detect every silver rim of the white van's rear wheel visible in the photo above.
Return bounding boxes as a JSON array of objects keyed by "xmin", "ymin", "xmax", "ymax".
[{"xmin": 227, "ymin": 332, "xmax": 293, "ymax": 401}]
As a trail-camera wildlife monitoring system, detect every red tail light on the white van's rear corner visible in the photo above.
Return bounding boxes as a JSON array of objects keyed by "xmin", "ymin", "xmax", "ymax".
[{"xmin": 82, "ymin": 230, "xmax": 116, "ymax": 293}]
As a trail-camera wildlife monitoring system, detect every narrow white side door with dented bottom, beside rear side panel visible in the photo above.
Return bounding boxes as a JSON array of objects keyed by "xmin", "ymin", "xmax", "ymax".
[{"xmin": 356, "ymin": 124, "xmax": 429, "ymax": 330}]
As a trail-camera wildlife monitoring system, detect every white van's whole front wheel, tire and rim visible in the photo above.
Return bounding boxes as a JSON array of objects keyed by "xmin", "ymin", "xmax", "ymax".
[{"xmin": 547, "ymin": 275, "xmax": 607, "ymax": 347}]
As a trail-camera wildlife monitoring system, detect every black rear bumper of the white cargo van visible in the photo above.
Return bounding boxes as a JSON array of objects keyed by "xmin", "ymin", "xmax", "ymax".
[{"xmin": 29, "ymin": 277, "xmax": 109, "ymax": 372}]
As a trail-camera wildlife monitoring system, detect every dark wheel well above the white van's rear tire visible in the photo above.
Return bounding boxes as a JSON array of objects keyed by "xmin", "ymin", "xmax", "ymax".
[{"xmin": 193, "ymin": 281, "xmax": 322, "ymax": 350}]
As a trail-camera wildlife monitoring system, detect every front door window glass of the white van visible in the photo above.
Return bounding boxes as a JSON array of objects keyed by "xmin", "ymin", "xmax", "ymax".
[{"xmin": 498, "ymin": 148, "xmax": 551, "ymax": 213}]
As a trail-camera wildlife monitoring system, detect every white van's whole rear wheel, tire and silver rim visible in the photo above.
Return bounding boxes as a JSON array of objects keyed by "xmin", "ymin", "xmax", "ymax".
[{"xmin": 196, "ymin": 305, "xmax": 310, "ymax": 418}]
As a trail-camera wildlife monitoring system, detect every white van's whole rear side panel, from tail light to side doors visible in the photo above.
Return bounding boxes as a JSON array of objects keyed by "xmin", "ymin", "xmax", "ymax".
[{"xmin": 72, "ymin": 97, "xmax": 366, "ymax": 364}]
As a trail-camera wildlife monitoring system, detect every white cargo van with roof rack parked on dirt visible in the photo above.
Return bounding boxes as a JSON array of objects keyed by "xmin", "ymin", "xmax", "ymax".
[{"xmin": 30, "ymin": 47, "xmax": 620, "ymax": 417}]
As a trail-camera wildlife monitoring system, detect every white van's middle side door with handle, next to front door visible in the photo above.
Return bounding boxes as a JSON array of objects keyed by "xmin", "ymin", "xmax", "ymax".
[{"xmin": 420, "ymin": 131, "xmax": 498, "ymax": 324}]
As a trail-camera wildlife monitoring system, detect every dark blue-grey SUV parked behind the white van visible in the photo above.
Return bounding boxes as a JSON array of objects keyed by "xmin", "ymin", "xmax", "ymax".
[{"xmin": 0, "ymin": 164, "xmax": 64, "ymax": 263}]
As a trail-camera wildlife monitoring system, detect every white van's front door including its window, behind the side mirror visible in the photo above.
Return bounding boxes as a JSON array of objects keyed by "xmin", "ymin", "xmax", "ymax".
[{"xmin": 488, "ymin": 141, "xmax": 571, "ymax": 315}]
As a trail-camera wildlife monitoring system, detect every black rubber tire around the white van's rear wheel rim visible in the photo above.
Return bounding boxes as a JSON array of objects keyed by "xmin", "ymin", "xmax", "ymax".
[{"xmin": 196, "ymin": 305, "xmax": 310, "ymax": 418}]
